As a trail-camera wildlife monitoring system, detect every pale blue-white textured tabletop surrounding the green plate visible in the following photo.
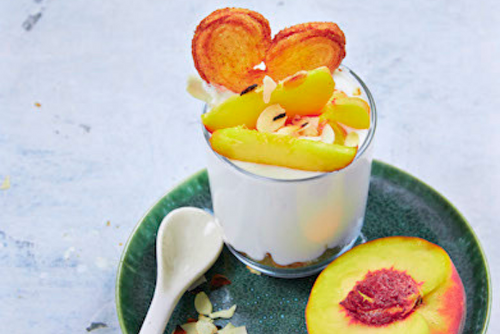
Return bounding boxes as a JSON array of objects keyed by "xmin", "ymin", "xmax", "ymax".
[{"xmin": 0, "ymin": 0, "xmax": 500, "ymax": 334}]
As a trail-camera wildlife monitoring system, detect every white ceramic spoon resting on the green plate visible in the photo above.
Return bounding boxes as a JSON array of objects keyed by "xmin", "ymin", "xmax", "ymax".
[{"xmin": 139, "ymin": 207, "xmax": 223, "ymax": 334}]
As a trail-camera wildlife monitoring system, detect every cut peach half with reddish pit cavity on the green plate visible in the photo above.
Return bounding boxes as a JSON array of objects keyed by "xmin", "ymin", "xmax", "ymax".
[{"xmin": 306, "ymin": 237, "xmax": 466, "ymax": 334}]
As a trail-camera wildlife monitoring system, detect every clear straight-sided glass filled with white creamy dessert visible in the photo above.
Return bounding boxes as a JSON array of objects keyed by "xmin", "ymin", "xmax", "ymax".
[{"xmin": 203, "ymin": 66, "xmax": 377, "ymax": 278}]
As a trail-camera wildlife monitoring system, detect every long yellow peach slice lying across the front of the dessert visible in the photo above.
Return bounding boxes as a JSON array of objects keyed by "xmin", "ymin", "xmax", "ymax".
[{"xmin": 210, "ymin": 127, "xmax": 357, "ymax": 172}]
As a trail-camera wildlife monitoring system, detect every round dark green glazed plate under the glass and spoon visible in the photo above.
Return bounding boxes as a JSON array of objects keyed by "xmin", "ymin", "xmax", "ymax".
[{"xmin": 116, "ymin": 161, "xmax": 491, "ymax": 334}]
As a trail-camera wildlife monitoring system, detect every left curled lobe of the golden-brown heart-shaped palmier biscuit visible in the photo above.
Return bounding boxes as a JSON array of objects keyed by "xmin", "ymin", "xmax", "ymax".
[{"xmin": 192, "ymin": 8, "xmax": 271, "ymax": 92}]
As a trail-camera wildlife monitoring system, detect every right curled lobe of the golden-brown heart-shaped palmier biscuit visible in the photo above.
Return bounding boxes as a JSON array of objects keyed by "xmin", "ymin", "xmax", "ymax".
[{"xmin": 264, "ymin": 22, "xmax": 345, "ymax": 80}]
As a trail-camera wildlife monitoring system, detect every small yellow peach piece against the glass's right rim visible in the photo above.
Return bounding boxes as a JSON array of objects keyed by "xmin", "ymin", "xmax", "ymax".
[{"xmin": 321, "ymin": 97, "xmax": 370, "ymax": 129}]
